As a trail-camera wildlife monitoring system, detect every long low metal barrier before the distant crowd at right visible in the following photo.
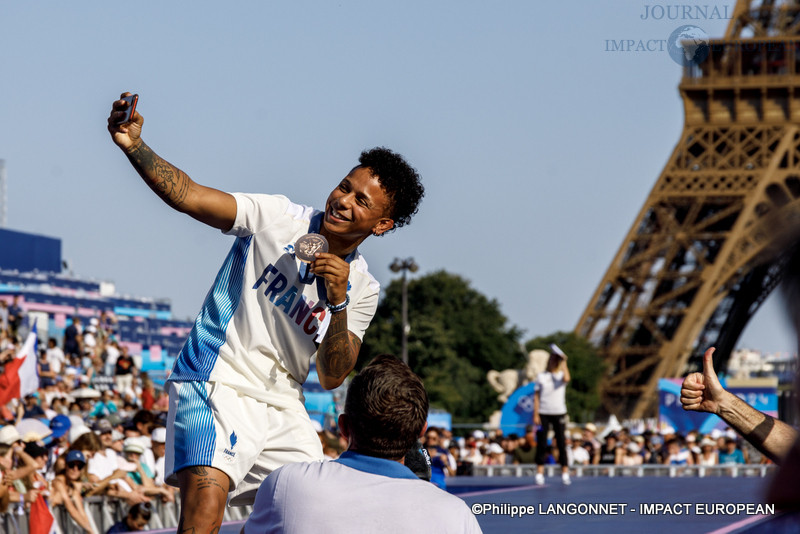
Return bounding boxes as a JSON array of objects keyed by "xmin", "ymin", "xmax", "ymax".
[{"xmin": 472, "ymin": 464, "xmax": 778, "ymax": 478}]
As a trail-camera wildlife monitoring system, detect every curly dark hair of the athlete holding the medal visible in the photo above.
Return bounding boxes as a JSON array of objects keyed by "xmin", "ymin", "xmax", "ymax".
[{"xmin": 358, "ymin": 147, "xmax": 425, "ymax": 235}]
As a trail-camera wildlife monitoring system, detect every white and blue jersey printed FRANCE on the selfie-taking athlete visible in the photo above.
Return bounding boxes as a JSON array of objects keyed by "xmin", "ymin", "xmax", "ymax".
[{"xmin": 170, "ymin": 193, "xmax": 380, "ymax": 408}]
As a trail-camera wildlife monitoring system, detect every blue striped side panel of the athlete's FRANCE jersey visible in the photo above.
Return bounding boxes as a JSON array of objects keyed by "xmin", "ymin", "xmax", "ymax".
[{"xmin": 169, "ymin": 236, "xmax": 253, "ymax": 381}]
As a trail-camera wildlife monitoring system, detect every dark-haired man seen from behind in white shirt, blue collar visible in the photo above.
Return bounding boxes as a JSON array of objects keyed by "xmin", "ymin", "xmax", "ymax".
[{"xmin": 242, "ymin": 355, "xmax": 481, "ymax": 534}]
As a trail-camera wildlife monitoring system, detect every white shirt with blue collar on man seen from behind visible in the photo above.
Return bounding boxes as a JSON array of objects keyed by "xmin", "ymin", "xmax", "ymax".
[{"xmin": 244, "ymin": 451, "xmax": 481, "ymax": 534}]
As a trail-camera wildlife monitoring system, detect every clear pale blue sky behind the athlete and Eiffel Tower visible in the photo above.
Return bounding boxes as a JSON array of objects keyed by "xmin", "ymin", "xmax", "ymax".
[{"xmin": 0, "ymin": 0, "xmax": 795, "ymax": 352}]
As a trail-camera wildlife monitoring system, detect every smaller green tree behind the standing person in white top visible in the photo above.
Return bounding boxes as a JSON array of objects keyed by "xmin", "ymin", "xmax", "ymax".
[{"xmin": 525, "ymin": 332, "xmax": 606, "ymax": 423}]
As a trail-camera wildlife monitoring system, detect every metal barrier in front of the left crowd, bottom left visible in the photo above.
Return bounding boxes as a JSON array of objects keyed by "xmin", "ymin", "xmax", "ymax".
[{"xmin": 0, "ymin": 497, "xmax": 253, "ymax": 534}]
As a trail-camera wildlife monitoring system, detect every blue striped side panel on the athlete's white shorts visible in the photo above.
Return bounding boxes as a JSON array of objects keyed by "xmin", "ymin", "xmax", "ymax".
[{"xmin": 174, "ymin": 382, "xmax": 217, "ymax": 473}]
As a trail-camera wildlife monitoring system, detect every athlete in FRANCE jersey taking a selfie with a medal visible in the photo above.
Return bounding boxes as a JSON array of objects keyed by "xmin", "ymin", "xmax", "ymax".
[{"xmin": 108, "ymin": 93, "xmax": 432, "ymax": 532}]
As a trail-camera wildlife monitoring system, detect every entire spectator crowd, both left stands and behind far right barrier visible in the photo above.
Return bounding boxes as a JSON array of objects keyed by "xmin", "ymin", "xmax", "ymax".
[{"xmin": 0, "ymin": 302, "xmax": 780, "ymax": 534}]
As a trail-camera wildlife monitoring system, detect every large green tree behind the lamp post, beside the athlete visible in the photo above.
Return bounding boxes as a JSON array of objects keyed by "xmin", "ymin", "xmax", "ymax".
[{"xmin": 359, "ymin": 271, "xmax": 525, "ymax": 422}]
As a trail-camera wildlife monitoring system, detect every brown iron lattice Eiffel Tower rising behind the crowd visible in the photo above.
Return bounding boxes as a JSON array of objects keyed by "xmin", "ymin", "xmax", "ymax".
[{"xmin": 576, "ymin": 0, "xmax": 800, "ymax": 418}]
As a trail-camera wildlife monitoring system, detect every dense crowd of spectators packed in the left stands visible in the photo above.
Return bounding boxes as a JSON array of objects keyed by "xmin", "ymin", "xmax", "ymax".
[{"xmin": 0, "ymin": 305, "xmax": 178, "ymax": 534}]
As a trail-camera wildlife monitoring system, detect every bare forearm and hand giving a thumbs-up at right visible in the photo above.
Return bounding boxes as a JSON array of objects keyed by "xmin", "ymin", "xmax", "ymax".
[{"xmin": 681, "ymin": 347, "xmax": 797, "ymax": 463}]
